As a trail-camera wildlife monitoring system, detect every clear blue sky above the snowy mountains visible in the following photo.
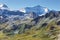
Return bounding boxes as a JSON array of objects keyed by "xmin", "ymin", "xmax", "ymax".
[{"xmin": 0, "ymin": 0, "xmax": 60, "ymax": 10}]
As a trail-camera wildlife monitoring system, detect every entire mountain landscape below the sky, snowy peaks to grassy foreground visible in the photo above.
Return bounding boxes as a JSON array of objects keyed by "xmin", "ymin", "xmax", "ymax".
[{"xmin": 0, "ymin": 4, "xmax": 60, "ymax": 40}]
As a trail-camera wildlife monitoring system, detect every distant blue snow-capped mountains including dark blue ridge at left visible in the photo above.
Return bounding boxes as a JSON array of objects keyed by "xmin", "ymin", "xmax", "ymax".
[{"xmin": 0, "ymin": 4, "xmax": 49, "ymax": 16}]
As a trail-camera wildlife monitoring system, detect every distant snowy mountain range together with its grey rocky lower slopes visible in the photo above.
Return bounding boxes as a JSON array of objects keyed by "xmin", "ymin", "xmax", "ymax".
[{"xmin": 0, "ymin": 4, "xmax": 49, "ymax": 21}]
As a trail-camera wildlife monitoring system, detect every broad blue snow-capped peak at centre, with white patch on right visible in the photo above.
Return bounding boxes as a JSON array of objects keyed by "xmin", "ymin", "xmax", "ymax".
[{"xmin": 24, "ymin": 5, "xmax": 49, "ymax": 15}]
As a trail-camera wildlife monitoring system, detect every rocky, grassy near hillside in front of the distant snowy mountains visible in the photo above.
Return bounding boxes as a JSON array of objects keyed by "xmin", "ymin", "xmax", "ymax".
[{"xmin": 0, "ymin": 11, "xmax": 60, "ymax": 40}]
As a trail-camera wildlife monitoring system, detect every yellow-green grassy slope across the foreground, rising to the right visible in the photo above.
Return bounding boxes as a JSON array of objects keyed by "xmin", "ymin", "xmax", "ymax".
[{"xmin": 0, "ymin": 21, "xmax": 60, "ymax": 40}]
